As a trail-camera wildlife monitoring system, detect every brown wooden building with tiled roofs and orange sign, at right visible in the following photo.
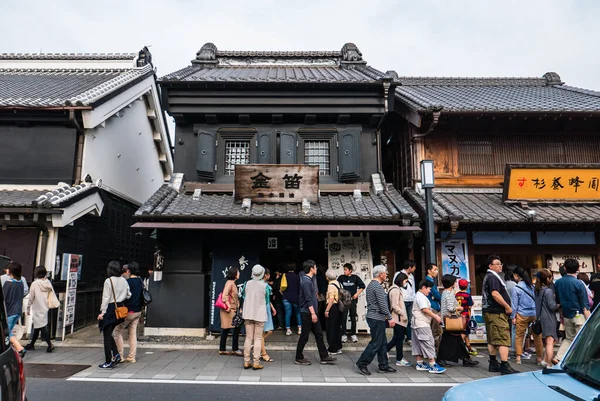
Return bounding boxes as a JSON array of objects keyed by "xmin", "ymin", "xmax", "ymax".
[{"xmin": 383, "ymin": 73, "xmax": 600, "ymax": 293}]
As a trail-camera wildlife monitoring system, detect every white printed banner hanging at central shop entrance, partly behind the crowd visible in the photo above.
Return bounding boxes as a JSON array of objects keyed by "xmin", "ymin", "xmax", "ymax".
[{"xmin": 327, "ymin": 233, "xmax": 373, "ymax": 331}]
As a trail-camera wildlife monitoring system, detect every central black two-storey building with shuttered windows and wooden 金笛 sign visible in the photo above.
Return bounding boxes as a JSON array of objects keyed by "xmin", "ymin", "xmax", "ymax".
[{"xmin": 134, "ymin": 43, "xmax": 420, "ymax": 335}]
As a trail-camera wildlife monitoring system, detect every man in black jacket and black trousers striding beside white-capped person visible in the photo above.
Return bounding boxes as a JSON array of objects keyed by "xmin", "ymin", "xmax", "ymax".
[{"xmin": 294, "ymin": 260, "xmax": 335, "ymax": 366}]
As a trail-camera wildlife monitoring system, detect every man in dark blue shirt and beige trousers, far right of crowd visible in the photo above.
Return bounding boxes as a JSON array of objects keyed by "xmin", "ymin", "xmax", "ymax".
[{"xmin": 554, "ymin": 259, "xmax": 590, "ymax": 360}]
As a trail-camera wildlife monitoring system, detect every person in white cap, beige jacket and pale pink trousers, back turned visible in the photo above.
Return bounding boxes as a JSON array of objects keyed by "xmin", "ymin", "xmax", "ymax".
[{"xmin": 242, "ymin": 265, "xmax": 268, "ymax": 370}]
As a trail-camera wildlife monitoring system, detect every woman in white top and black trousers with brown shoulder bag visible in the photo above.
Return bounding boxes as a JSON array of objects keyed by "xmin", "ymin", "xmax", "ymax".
[{"xmin": 98, "ymin": 261, "xmax": 131, "ymax": 369}]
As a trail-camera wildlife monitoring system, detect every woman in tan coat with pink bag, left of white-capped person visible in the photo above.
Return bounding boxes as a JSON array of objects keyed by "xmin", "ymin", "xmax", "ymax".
[{"xmin": 219, "ymin": 267, "xmax": 244, "ymax": 356}]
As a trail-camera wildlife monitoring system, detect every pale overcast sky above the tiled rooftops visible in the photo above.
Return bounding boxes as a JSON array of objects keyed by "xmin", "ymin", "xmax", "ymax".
[{"xmin": 0, "ymin": 0, "xmax": 600, "ymax": 90}]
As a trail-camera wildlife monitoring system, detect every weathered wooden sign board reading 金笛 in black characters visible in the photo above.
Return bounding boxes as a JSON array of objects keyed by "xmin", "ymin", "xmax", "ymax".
[{"xmin": 234, "ymin": 164, "xmax": 319, "ymax": 203}]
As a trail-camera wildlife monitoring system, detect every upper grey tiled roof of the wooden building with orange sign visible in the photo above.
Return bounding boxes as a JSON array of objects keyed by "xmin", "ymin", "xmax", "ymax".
[{"xmin": 396, "ymin": 73, "xmax": 600, "ymax": 113}]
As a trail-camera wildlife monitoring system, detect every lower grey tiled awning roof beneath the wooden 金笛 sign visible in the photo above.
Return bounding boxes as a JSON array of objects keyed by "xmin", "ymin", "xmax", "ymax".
[{"xmin": 136, "ymin": 184, "xmax": 418, "ymax": 222}]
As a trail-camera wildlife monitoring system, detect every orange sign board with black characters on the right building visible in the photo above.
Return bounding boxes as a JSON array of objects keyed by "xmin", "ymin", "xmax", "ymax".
[{"xmin": 504, "ymin": 164, "xmax": 600, "ymax": 203}]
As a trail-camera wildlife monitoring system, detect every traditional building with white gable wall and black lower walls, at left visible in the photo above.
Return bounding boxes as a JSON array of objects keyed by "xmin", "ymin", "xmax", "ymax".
[{"xmin": 0, "ymin": 48, "xmax": 173, "ymax": 334}]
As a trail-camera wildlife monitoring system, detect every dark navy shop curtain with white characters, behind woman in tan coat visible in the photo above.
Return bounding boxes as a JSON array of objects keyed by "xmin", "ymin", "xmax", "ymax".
[{"xmin": 210, "ymin": 244, "xmax": 258, "ymax": 331}]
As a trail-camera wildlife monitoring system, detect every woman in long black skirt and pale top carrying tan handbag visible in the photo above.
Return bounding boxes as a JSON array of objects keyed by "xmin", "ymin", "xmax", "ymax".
[{"xmin": 438, "ymin": 274, "xmax": 479, "ymax": 366}]
